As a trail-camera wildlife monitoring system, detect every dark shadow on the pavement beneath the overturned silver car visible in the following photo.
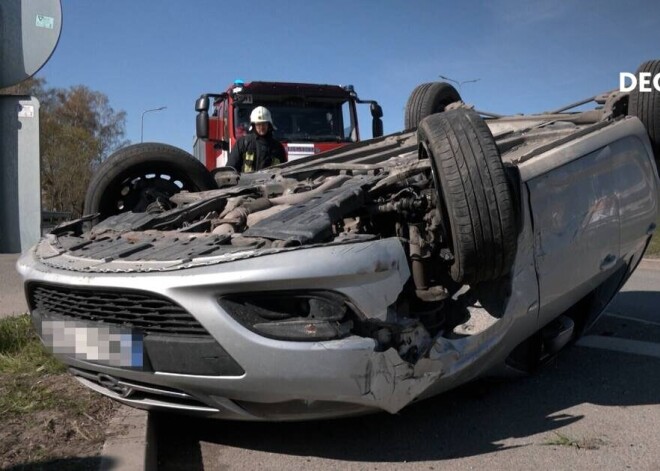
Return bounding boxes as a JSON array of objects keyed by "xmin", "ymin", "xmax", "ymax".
[{"xmin": 158, "ymin": 347, "xmax": 660, "ymax": 469}]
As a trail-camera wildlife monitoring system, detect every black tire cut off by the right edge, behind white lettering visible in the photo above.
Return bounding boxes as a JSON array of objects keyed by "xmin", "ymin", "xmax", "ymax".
[{"xmin": 628, "ymin": 60, "xmax": 660, "ymax": 173}]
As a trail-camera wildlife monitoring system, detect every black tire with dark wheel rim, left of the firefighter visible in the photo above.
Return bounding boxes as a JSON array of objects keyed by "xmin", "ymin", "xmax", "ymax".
[{"xmin": 84, "ymin": 143, "xmax": 217, "ymax": 222}]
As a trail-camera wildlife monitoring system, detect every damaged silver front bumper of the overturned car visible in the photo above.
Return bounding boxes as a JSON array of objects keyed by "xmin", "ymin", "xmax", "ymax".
[{"xmin": 18, "ymin": 238, "xmax": 529, "ymax": 420}]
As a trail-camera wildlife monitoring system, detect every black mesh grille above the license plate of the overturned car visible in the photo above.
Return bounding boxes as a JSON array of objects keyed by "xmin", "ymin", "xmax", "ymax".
[{"xmin": 28, "ymin": 284, "xmax": 210, "ymax": 336}]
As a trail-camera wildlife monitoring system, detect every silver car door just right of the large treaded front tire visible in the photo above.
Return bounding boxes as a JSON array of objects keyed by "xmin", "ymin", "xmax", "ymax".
[{"xmin": 527, "ymin": 145, "xmax": 623, "ymax": 325}]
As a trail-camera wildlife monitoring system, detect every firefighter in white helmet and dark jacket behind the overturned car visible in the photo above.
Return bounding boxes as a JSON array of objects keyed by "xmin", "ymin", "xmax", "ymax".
[{"xmin": 227, "ymin": 106, "xmax": 286, "ymax": 173}]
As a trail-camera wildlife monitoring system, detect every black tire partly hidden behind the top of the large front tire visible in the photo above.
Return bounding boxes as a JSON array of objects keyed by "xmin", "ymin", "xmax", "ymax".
[{"xmin": 404, "ymin": 82, "xmax": 461, "ymax": 129}]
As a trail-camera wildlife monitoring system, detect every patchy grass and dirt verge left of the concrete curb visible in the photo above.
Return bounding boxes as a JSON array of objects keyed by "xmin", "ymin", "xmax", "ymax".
[{"xmin": 0, "ymin": 315, "xmax": 117, "ymax": 469}]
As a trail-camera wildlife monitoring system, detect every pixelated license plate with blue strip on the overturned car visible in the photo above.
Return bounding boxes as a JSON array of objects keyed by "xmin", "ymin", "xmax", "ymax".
[{"xmin": 41, "ymin": 319, "xmax": 144, "ymax": 368}]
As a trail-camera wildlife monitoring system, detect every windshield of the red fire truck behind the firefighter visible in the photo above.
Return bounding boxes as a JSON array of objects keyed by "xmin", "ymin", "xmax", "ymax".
[{"xmin": 234, "ymin": 97, "xmax": 355, "ymax": 142}]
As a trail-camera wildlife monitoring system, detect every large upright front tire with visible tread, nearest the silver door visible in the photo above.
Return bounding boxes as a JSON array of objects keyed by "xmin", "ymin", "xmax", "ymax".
[{"xmin": 417, "ymin": 109, "xmax": 518, "ymax": 284}]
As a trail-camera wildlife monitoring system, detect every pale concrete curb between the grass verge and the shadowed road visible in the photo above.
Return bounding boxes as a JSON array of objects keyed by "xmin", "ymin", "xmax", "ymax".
[{"xmin": 99, "ymin": 405, "xmax": 157, "ymax": 471}]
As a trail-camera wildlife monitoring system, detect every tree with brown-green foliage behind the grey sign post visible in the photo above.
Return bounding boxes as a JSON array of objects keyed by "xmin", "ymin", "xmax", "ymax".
[{"xmin": 0, "ymin": 78, "xmax": 128, "ymax": 217}]
